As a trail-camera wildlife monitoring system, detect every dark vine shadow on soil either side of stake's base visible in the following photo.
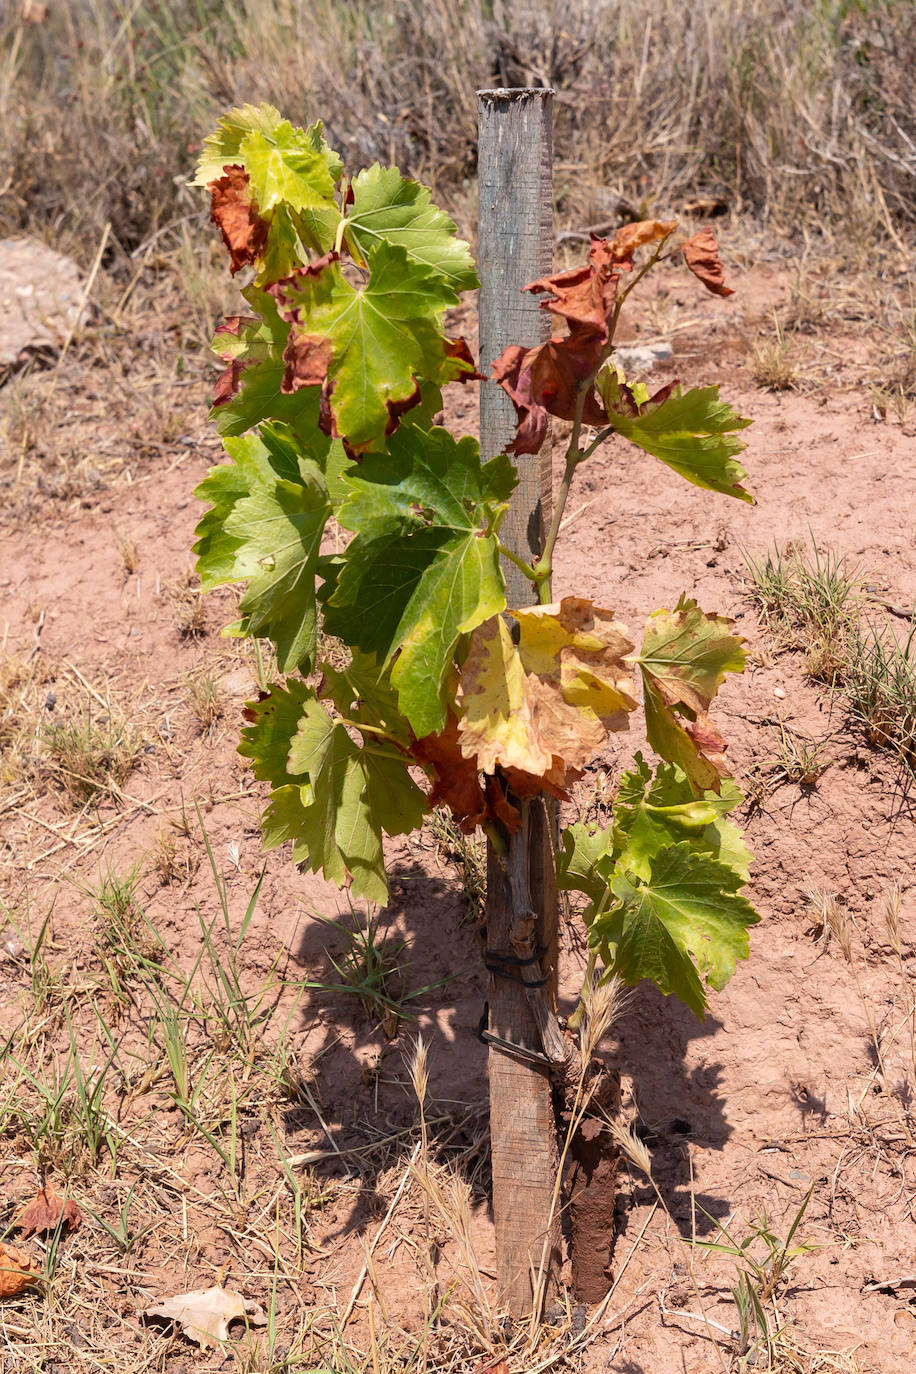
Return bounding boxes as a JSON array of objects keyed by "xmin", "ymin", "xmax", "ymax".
[{"xmin": 280, "ymin": 864, "xmax": 731, "ymax": 1238}]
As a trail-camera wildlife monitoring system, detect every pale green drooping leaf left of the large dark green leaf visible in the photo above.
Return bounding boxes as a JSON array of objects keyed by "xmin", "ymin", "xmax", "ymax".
[{"xmin": 224, "ymin": 462, "xmax": 331, "ymax": 673}]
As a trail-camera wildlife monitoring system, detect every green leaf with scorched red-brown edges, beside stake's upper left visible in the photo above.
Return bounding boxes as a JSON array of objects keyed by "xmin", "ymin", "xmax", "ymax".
[{"xmin": 271, "ymin": 242, "xmax": 461, "ymax": 452}]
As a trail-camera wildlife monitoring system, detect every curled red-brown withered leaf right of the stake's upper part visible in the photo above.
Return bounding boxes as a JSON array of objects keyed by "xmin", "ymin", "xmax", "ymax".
[{"xmin": 492, "ymin": 220, "xmax": 677, "ymax": 455}]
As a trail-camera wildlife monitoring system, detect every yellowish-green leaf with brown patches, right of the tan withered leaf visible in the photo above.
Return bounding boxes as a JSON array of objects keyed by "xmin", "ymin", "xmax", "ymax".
[{"xmin": 633, "ymin": 598, "xmax": 746, "ymax": 794}]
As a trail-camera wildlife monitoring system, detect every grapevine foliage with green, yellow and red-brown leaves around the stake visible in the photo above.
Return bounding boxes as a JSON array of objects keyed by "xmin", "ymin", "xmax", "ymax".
[{"xmin": 195, "ymin": 106, "xmax": 758, "ymax": 1059}]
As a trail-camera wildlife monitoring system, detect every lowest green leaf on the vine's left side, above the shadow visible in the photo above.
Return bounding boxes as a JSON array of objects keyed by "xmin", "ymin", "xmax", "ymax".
[{"xmin": 286, "ymin": 701, "xmax": 426, "ymax": 903}]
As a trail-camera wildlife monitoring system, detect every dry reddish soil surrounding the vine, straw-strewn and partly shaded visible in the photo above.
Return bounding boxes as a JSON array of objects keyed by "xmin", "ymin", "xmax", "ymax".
[{"xmin": 0, "ymin": 250, "xmax": 916, "ymax": 1374}]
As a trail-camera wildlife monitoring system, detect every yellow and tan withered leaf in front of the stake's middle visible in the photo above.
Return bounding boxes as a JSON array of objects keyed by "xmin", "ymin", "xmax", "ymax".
[{"xmin": 457, "ymin": 596, "xmax": 636, "ymax": 798}]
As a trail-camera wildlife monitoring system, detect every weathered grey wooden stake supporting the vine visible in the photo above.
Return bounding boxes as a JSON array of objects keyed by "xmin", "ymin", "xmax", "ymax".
[{"xmin": 478, "ymin": 89, "xmax": 559, "ymax": 1316}]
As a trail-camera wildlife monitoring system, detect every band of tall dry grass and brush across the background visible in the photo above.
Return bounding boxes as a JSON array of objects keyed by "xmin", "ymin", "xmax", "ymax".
[{"xmin": 0, "ymin": 0, "xmax": 916, "ymax": 260}]
